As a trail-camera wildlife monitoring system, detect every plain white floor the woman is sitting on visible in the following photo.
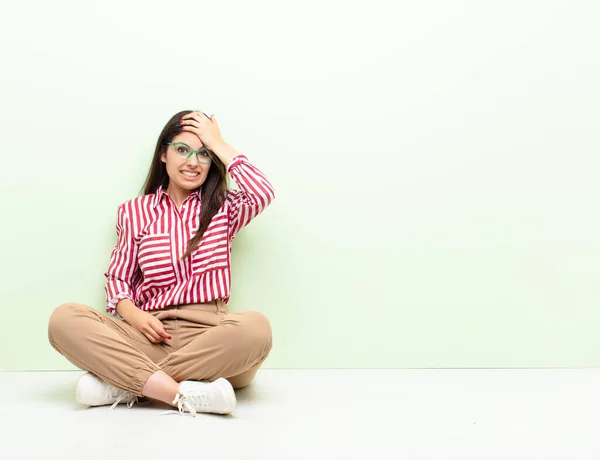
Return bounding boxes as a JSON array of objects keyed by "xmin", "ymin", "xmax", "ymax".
[{"xmin": 0, "ymin": 369, "xmax": 600, "ymax": 460}]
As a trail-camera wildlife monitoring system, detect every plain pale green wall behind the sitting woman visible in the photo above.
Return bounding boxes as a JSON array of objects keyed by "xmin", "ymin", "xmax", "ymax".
[{"xmin": 0, "ymin": 0, "xmax": 600, "ymax": 370}]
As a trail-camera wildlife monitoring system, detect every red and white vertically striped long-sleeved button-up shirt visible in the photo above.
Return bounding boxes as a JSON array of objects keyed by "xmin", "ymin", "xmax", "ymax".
[{"xmin": 104, "ymin": 154, "xmax": 275, "ymax": 316}]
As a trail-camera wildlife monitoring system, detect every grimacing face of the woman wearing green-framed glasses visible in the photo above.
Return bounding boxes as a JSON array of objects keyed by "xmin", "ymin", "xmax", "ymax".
[{"xmin": 160, "ymin": 132, "xmax": 212, "ymax": 193}]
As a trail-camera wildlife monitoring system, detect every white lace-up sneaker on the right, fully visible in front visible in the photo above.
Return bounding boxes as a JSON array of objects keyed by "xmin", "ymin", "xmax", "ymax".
[{"xmin": 173, "ymin": 378, "xmax": 237, "ymax": 416}]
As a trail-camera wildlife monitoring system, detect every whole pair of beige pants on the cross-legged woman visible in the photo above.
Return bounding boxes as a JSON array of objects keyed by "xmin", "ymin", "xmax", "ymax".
[{"xmin": 48, "ymin": 301, "xmax": 272, "ymax": 396}]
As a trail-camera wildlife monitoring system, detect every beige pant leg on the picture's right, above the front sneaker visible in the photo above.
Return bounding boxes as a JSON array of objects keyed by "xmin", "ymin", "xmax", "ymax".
[{"xmin": 158, "ymin": 306, "xmax": 272, "ymax": 388}]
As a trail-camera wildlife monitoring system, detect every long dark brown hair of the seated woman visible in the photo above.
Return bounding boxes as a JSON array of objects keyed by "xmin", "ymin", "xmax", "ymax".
[{"xmin": 142, "ymin": 110, "xmax": 227, "ymax": 260}]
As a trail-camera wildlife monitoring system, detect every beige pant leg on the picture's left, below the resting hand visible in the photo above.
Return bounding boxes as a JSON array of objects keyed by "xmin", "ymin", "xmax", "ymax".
[{"xmin": 48, "ymin": 303, "xmax": 173, "ymax": 396}]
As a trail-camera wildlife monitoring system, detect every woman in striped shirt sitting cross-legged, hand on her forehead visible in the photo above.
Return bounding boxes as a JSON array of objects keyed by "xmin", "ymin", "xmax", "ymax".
[{"xmin": 48, "ymin": 111, "xmax": 274, "ymax": 415}]
